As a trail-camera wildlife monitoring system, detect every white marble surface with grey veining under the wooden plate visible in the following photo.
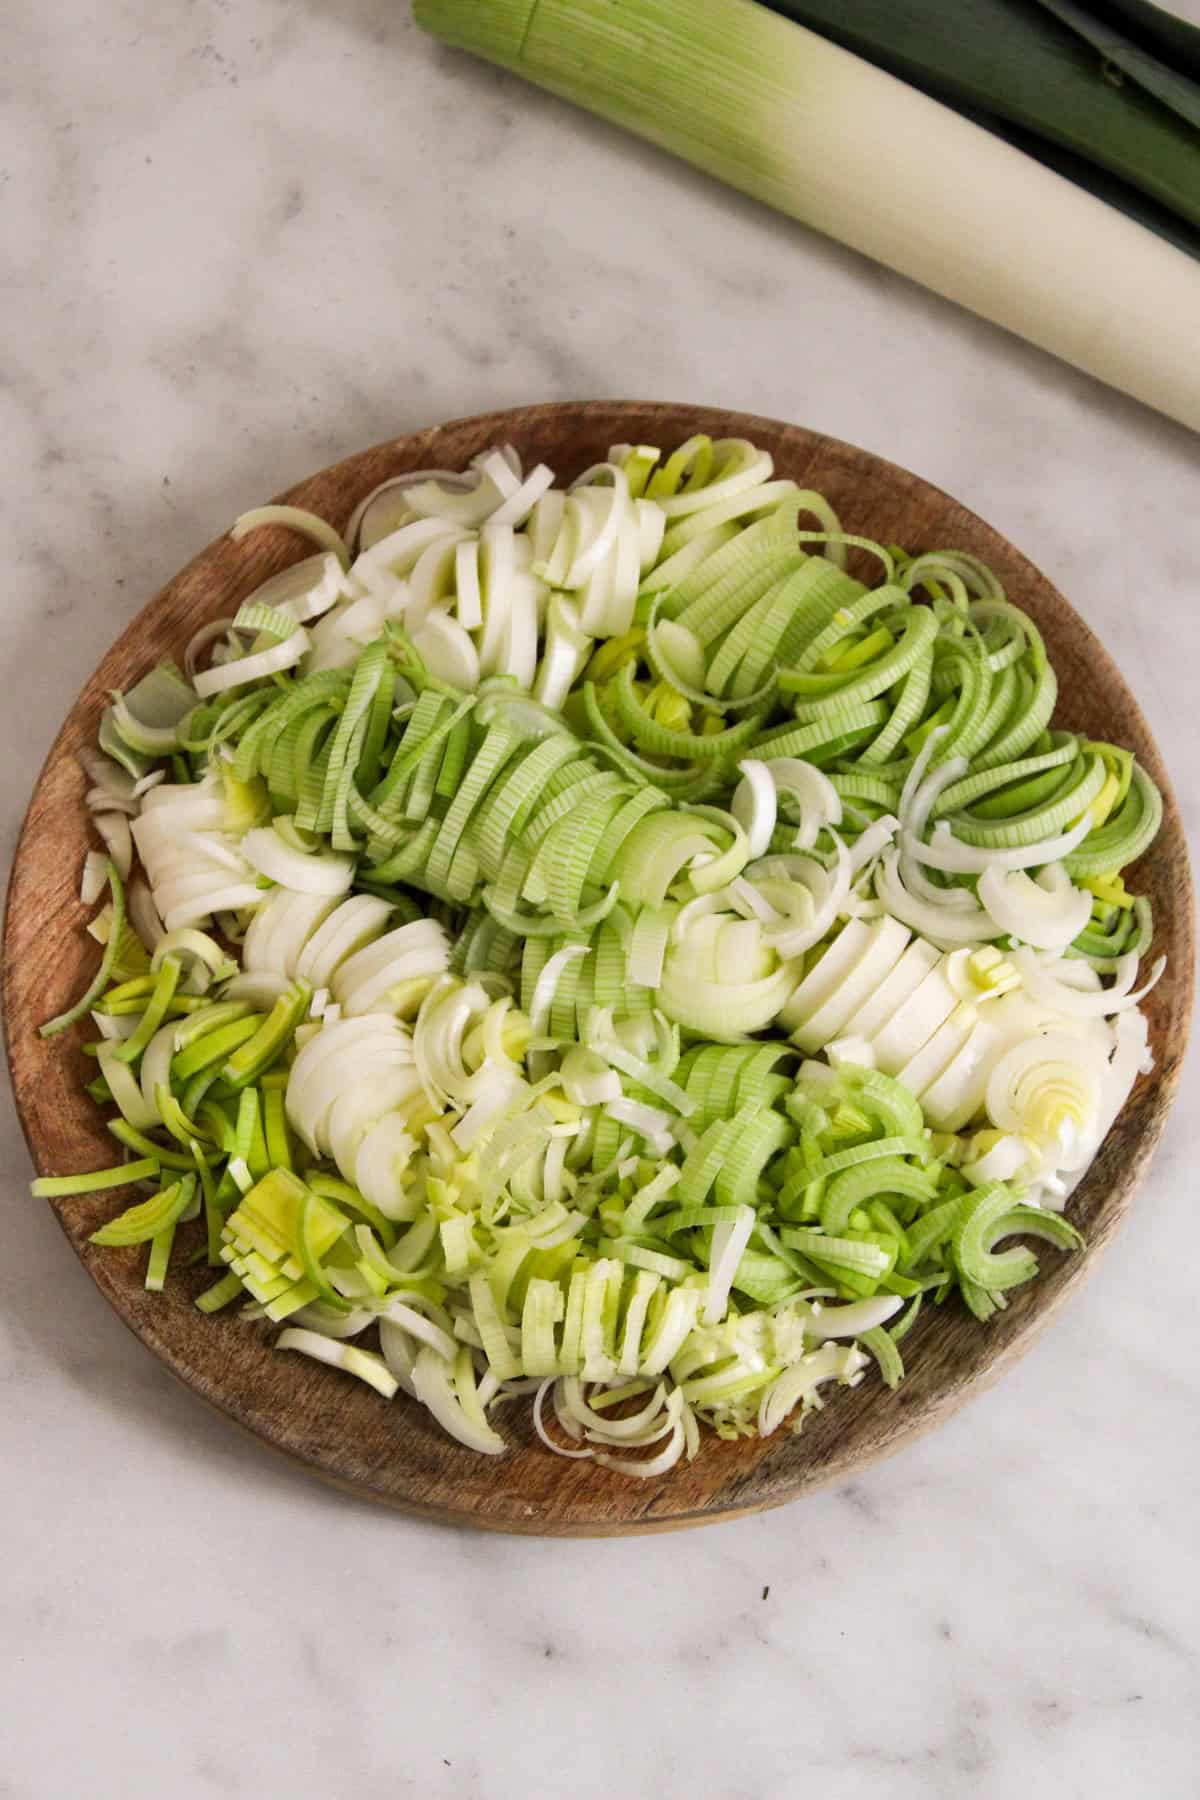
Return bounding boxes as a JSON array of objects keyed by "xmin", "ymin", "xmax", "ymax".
[{"xmin": 0, "ymin": 0, "xmax": 1200, "ymax": 1800}]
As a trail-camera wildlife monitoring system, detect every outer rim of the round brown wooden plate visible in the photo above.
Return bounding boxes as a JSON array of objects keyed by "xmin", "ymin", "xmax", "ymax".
[{"xmin": 4, "ymin": 401, "xmax": 1195, "ymax": 1537}]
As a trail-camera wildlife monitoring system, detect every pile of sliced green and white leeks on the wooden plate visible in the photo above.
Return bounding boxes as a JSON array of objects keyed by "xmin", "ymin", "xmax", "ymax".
[{"xmin": 34, "ymin": 437, "xmax": 1162, "ymax": 1476}]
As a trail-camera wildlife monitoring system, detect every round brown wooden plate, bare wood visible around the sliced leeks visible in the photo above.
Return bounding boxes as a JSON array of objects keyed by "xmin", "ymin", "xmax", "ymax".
[{"xmin": 4, "ymin": 401, "xmax": 1193, "ymax": 1535}]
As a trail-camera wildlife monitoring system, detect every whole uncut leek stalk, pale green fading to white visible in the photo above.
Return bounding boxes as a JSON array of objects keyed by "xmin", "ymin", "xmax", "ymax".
[{"xmin": 416, "ymin": 0, "xmax": 1200, "ymax": 428}]
